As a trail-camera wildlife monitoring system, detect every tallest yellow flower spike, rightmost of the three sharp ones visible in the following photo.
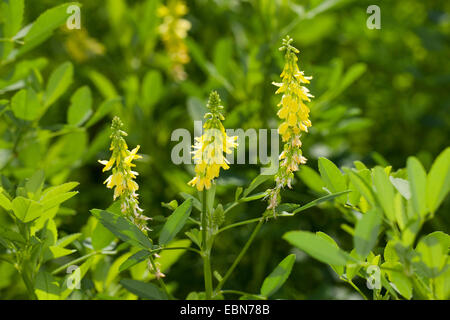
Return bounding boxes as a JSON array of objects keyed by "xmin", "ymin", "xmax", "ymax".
[{"xmin": 267, "ymin": 36, "xmax": 313, "ymax": 211}]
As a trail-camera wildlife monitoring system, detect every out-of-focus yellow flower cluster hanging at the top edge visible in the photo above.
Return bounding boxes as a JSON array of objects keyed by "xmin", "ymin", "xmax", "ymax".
[{"xmin": 158, "ymin": 0, "xmax": 191, "ymax": 80}]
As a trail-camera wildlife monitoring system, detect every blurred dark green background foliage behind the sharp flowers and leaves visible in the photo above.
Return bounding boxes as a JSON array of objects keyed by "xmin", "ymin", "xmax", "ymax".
[{"xmin": 0, "ymin": 0, "xmax": 450, "ymax": 299}]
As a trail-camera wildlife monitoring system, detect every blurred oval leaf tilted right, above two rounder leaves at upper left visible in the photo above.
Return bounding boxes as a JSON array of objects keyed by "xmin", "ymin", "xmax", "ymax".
[{"xmin": 44, "ymin": 62, "xmax": 73, "ymax": 108}]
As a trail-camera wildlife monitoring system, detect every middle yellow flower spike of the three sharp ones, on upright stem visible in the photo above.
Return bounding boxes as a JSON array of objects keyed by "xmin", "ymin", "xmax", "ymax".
[{"xmin": 188, "ymin": 91, "xmax": 238, "ymax": 191}]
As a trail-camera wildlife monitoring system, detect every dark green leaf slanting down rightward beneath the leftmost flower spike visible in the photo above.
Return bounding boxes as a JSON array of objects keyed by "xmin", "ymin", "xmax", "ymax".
[{"xmin": 91, "ymin": 209, "xmax": 153, "ymax": 249}]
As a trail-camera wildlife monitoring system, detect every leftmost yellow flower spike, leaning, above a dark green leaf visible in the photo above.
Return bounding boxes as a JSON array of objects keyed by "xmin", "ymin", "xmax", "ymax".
[{"xmin": 99, "ymin": 117, "xmax": 150, "ymax": 231}]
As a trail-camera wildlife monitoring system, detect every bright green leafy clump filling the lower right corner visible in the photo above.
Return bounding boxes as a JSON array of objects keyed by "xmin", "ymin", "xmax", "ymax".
[{"xmin": 283, "ymin": 148, "xmax": 450, "ymax": 299}]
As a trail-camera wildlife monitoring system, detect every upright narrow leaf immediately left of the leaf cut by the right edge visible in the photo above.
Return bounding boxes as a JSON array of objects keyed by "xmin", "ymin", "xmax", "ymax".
[{"xmin": 406, "ymin": 157, "xmax": 427, "ymax": 217}]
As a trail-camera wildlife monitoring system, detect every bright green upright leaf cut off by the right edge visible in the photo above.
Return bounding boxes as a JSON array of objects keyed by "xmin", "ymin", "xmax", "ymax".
[{"xmin": 427, "ymin": 147, "xmax": 450, "ymax": 213}]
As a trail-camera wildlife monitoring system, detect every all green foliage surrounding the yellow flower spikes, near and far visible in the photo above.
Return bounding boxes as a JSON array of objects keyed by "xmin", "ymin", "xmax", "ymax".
[{"xmin": 0, "ymin": 0, "xmax": 450, "ymax": 300}]
